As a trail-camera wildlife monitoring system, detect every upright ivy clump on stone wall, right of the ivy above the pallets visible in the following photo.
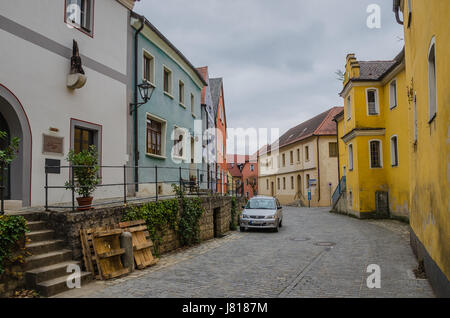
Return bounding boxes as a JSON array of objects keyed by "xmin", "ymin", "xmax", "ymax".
[{"xmin": 178, "ymin": 198, "xmax": 204, "ymax": 246}]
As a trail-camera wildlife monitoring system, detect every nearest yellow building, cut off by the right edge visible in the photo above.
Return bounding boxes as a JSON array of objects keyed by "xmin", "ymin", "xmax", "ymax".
[{"xmin": 394, "ymin": 0, "xmax": 450, "ymax": 297}]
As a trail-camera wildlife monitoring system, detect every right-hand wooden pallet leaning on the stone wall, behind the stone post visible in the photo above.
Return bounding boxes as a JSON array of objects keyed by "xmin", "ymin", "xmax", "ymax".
[{"xmin": 119, "ymin": 220, "xmax": 158, "ymax": 269}]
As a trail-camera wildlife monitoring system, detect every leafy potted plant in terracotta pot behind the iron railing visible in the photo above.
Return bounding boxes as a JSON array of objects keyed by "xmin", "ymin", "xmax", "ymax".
[{"xmin": 66, "ymin": 146, "xmax": 100, "ymax": 211}]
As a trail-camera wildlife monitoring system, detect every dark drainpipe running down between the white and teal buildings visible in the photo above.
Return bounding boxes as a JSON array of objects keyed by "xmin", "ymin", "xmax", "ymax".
[{"xmin": 133, "ymin": 15, "xmax": 145, "ymax": 192}]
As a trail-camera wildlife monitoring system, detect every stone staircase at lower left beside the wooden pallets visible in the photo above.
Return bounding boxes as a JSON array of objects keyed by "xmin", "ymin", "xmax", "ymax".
[{"xmin": 20, "ymin": 213, "xmax": 92, "ymax": 297}]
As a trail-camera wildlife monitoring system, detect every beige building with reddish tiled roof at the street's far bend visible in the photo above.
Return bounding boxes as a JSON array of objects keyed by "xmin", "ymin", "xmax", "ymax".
[{"xmin": 258, "ymin": 107, "xmax": 343, "ymax": 207}]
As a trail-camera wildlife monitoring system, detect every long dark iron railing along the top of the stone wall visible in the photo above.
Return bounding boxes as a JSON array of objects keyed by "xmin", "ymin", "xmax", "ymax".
[{"xmin": 44, "ymin": 165, "xmax": 244, "ymax": 211}]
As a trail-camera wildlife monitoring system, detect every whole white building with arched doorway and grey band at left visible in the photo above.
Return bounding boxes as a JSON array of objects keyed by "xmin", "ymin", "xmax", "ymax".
[{"xmin": 0, "ymin": 0, "xmax": 134, "ymax": 206}]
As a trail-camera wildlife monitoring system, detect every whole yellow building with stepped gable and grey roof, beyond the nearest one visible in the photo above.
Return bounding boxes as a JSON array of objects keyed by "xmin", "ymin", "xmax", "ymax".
[{"xmin": 334, "ymin": 51, "xmax": 409, "ymax": 220}]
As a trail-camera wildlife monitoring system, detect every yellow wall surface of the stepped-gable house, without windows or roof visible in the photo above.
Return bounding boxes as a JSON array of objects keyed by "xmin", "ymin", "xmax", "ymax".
[{"xmin": 338, "ymin": 58, "xmax": 409, "ymax": 218}]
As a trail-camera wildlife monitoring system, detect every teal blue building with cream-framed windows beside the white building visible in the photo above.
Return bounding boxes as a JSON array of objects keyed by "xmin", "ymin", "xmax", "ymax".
[{"xmin": 130, "ymin": 14, "xmax": 208, "ymax": 197}]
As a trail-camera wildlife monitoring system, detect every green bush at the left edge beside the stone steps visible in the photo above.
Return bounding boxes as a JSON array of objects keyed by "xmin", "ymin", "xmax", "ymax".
[{"xmin": 0, "ymin": 215, "xmax": 28, "ymax": 274}]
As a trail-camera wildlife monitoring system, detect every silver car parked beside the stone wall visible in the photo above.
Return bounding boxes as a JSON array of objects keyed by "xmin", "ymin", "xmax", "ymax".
[{"xmin": 239, "ymin": 196, "xmax": 283, "ymax": 232}]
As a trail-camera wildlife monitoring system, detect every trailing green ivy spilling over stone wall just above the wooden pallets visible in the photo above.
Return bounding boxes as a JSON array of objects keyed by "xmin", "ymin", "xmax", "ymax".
[{"xmin": 122, "ymin": 199, "xmax": 179, "ymax": 255}]
